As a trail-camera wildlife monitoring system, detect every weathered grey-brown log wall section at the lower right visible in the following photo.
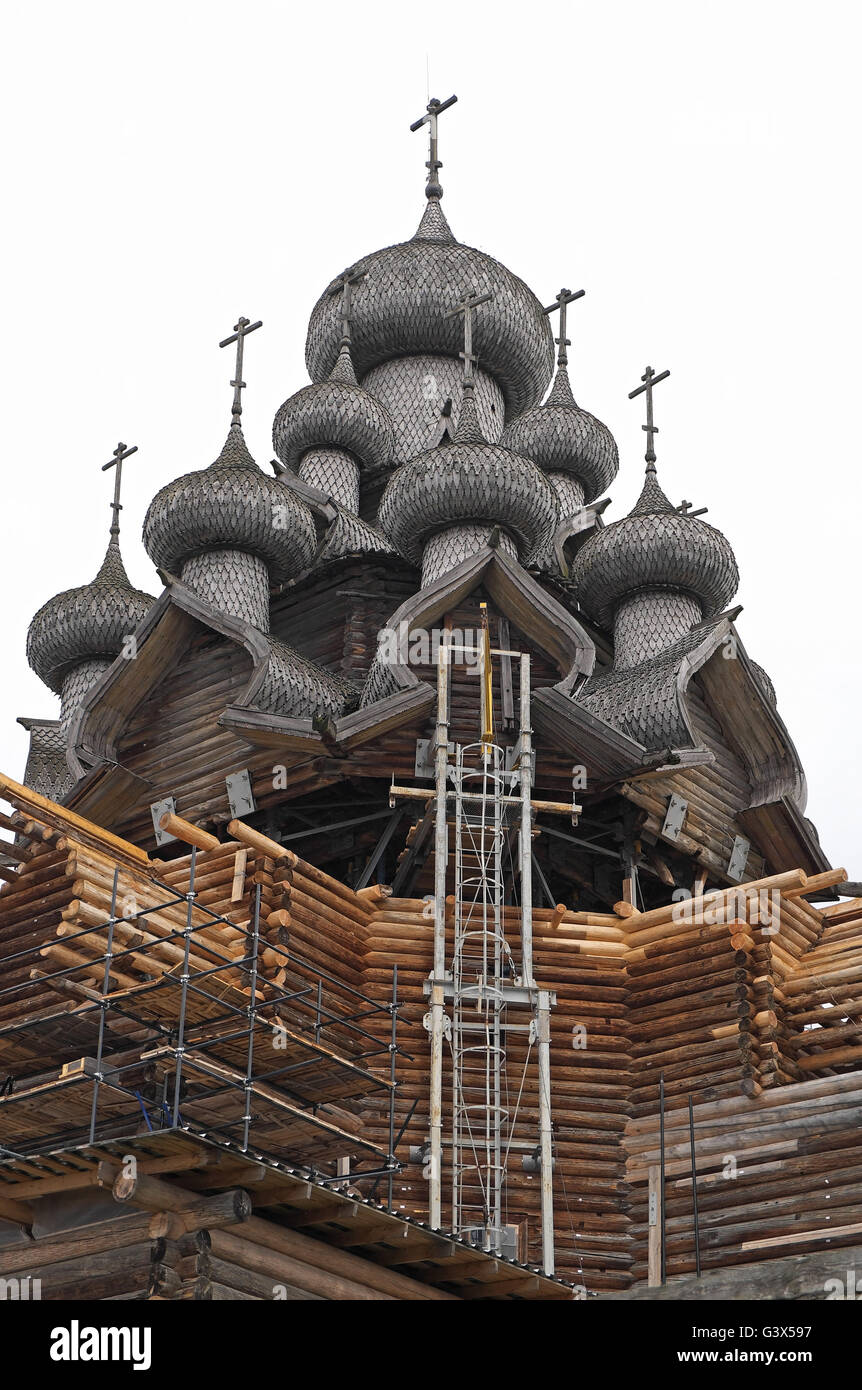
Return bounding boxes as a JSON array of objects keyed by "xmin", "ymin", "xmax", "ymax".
[{"xmin": 626, "ymin": 1073, "xmax": 862, "ymax": 1283}]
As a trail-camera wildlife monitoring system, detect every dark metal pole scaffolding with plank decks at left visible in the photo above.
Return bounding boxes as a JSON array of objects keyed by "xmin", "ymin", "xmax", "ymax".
[{"xmin": 0, "ymin": 848, "xmax": 409, "ymax": 1209}]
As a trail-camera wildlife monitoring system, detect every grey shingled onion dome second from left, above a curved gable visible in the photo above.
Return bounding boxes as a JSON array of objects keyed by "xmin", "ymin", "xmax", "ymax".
[{"xmin": 143, "ymin": 421, "xmax": 317, "ymax": 584}]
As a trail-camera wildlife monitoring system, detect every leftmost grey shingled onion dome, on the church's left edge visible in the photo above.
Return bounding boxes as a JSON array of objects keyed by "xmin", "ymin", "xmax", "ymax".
[{"xmin": 26, "ymin": 527, "xmax": 154, "ymax": 695}]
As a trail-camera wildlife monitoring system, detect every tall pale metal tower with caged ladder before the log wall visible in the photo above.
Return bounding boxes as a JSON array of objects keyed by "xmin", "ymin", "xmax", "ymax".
[{"xmin": 391, "ymin": 626, "xmax": 580, "ymax": 1273}]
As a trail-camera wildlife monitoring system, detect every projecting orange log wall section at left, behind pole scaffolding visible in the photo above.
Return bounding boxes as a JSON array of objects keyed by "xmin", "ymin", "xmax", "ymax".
[{"xmin": 0, "ymin": 808, "xmax": 382, "ymax": 1162}]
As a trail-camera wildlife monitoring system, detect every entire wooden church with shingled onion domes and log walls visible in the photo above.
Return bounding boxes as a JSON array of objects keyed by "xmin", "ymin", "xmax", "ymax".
[{"xmin": 0, "ymin": 99, "xmax": 862, "ymax": 1300}]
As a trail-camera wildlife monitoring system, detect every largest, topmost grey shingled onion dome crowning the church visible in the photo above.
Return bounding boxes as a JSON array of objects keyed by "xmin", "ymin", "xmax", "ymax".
[{"xmin": 306, "ymin": 197, "xmax": 553, "ymax": 417}]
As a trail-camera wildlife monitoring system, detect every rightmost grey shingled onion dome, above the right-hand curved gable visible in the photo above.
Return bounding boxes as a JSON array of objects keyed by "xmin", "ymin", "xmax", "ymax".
[{"xmin": 571, "ymin": 463, "xmax": 740, "ymax": 627}]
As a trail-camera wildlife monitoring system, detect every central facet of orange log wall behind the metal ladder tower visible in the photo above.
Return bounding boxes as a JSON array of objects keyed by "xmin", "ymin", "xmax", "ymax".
[{"xmin": 355, "ymin": 898, "xmax": 630, "ymax": 1290}]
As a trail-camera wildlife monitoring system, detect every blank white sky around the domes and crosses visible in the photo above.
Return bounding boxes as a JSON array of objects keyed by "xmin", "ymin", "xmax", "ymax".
[{"xmin": 0, "ymin": 0, "xmax": 862, "ymax": 878}]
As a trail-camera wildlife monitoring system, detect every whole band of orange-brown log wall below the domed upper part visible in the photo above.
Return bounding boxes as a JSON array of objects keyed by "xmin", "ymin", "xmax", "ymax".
[{"xmin": 0, "ymin": 789, "xmax": 862, "ymax": 1297}]
